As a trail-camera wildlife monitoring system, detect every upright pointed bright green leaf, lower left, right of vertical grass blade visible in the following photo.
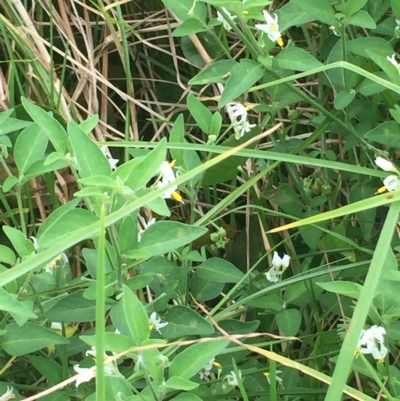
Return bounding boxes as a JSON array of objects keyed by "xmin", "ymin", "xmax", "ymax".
[{"xmin": 122, "ymin": 285, "xmax": 150, "ymax": 345}]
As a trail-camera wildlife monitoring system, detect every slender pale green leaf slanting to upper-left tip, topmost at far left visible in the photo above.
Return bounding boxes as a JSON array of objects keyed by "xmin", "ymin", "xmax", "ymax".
[{"xmin": 21, "ymin": 97, "xmax": 67, "ymax": 155}]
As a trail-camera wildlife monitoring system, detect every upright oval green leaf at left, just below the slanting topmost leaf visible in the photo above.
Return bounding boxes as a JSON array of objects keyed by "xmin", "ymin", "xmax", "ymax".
[{"xmin": 14, "ymin": 124, "xmax": 49, "ymax": 176}]
